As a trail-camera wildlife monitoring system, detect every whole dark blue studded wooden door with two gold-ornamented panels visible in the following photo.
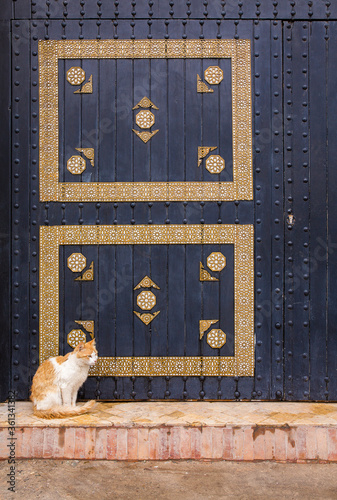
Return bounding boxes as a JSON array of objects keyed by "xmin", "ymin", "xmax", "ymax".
[{"xmin": 7, "ymin": 0, "xmax": 337, "ymax": 400}]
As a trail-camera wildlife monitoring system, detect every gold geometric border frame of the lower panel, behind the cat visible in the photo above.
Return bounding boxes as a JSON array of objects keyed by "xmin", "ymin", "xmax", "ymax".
[{"xmin": 39, "ymin": 224, "xmax": 254, "ymax": 377}]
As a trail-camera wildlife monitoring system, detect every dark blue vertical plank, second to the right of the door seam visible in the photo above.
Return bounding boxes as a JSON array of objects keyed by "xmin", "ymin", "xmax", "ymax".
[{"xmin": 307, "ymin": 22, "xmax": 329, "ymax": 400}]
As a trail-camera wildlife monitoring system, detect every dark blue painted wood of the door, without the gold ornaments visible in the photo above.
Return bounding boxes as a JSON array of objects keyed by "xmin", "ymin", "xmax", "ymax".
[{"xmin": 5, "ymin": 0, "xmax": 337, "ymax": 400}]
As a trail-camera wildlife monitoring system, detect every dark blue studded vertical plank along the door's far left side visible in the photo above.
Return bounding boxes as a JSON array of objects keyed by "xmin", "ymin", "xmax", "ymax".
[{"xmin": 11, "ymin": 20, "xmax": 30, "ymax": 399}]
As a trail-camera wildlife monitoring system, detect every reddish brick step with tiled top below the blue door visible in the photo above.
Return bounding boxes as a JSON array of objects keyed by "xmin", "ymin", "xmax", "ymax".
[{"xmin": 0, "ymin": 402, "xmax": 337, "ymax": 462}]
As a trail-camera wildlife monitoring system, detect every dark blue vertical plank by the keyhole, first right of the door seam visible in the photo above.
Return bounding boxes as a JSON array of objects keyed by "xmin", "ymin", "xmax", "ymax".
[{"xmin": 285, "ymin": 22, "xmax": 310, "ymax": 399}]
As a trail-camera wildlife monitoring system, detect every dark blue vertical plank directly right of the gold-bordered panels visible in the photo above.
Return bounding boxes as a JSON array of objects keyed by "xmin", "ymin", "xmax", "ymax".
[{"xmin": 252, "ymin": 21, "xmax": 270, "ymax": 399}]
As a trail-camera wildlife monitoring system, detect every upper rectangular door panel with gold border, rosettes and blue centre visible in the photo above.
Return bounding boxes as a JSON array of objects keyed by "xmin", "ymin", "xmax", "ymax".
[{"xmin": 39, "ymin": 40, "xmax": 253, "ymax": 202}]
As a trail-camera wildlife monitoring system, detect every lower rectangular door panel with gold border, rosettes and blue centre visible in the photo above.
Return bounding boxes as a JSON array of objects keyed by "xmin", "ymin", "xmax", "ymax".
[{"xmin": 39, "ymin": 224, "xmax": 254, "ymax": 377}]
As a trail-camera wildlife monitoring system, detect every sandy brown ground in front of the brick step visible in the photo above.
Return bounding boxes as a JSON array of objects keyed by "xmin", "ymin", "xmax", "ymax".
[{"xmin": 0, "ymin": 460, "xmax": 337, "ymax": 500}]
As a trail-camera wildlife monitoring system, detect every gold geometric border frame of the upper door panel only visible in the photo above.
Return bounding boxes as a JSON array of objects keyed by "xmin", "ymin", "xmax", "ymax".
[{"xmin": 39, "ymin": 40, "xmax": 253, "ymax": 202}]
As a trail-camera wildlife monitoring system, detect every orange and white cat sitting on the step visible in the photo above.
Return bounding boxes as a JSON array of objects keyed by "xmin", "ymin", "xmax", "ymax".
[{"xmin": 30, "ymin": 339, "xmax": 98, "ymax": 418}]
